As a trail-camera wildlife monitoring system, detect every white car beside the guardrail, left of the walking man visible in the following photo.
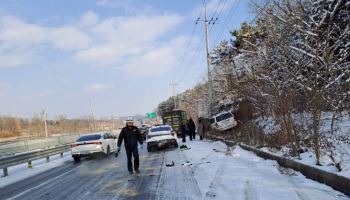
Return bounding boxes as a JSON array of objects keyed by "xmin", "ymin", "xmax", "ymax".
[{"xmin": 71, "ymin": 132, "xmax": 117, "ymax": 162}]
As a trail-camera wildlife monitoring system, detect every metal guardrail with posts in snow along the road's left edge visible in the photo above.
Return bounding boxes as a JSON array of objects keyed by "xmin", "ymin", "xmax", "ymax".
[{"xmin": 0, "ymin": 145, "xmax": 70, "ymax": 176}]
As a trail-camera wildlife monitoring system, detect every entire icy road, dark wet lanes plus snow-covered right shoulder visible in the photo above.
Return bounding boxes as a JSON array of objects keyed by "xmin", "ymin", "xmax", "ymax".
[{"xmin": 0, "ymin": 141, "xmax": 349, "ymax": 200}]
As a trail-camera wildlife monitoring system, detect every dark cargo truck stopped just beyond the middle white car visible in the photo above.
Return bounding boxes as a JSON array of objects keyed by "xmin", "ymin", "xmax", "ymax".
[{"xmin": 162, "ymin": 110, "xmax": 187, "ymax": 134}]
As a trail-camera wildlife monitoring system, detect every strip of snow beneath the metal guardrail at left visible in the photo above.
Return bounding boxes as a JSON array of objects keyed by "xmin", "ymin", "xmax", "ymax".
[{"xmin": 0, "ymin": 151, "xmax": 73, "ymax": 188}]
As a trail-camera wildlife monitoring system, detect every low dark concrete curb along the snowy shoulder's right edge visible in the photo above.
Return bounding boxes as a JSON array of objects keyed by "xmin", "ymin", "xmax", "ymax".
[{"xmin": 207, "ymin": 136, "xmax": 350, "ymax": 196}]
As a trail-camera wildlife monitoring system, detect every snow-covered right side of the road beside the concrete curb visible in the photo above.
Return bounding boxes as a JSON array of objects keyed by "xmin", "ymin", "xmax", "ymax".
[{"xmin": 183, "ymin": 141, "xmax": 349, "ymax": 200}]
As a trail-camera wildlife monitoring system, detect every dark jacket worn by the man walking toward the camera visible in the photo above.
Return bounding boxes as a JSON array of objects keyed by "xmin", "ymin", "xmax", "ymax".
[{"xmin": 118, "ymin": 126, "xmax": 143, "ymax": 148}]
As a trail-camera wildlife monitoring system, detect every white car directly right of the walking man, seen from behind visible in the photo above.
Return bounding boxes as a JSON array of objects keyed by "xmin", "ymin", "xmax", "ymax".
[{"xmin": 146, "ymin": 125, "xmax": 179, "ymax": 152}]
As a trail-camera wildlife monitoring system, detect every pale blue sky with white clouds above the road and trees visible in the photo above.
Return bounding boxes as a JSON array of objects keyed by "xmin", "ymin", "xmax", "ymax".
[{"xmin": 0, "ymin": 0, "xmax": 252, "ymax": 118}]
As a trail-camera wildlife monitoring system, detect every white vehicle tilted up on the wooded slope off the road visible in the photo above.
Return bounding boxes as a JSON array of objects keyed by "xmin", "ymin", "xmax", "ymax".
[{"xmin": 210, "ymin": 112, "xmax": 237, "ymax": 131}]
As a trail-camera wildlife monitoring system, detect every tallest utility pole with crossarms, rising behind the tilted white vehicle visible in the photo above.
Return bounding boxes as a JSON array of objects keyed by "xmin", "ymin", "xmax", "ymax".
[{"xmin": 196, "ymin": 5, "xmax": 218, "ymax": 118}]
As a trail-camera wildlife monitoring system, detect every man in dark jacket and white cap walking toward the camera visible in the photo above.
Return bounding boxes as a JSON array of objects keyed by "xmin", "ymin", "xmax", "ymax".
[{"xmin": 117, "ymin": 119, "xmax": 143, "ymax": 174}]
